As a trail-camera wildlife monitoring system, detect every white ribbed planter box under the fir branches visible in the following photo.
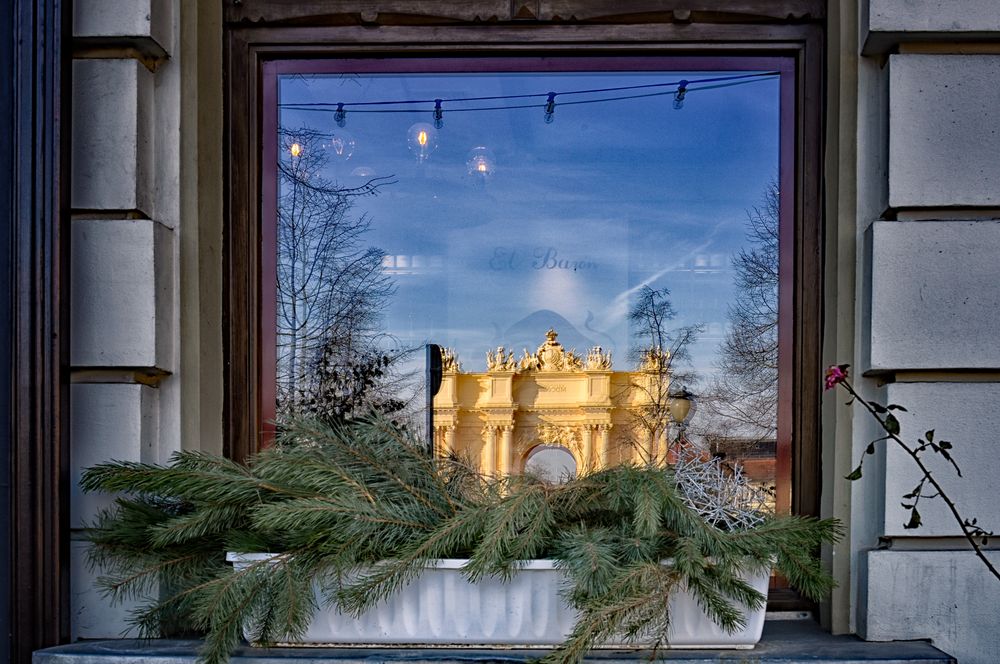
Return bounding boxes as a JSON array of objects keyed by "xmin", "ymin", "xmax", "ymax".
[{"xmin": 227, "ymin": 553, "xmax": 768, "ymax": 649}]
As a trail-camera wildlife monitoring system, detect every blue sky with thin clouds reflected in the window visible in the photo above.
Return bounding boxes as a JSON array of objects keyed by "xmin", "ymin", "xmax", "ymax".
[{"xmin": 280, "ymin": 72, "xmax": 779, "ymax": 376}]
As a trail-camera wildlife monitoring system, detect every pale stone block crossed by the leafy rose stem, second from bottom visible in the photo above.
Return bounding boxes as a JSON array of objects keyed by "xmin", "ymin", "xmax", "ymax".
[{"xmin": 885, "ymin": 382, "xmax": 1000, "ymax": 536}]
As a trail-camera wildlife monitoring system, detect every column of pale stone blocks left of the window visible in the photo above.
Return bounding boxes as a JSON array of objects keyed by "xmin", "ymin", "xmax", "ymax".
[{"xmin": 70, "ymin": 0, "xmax": 180, "ymax": 638}]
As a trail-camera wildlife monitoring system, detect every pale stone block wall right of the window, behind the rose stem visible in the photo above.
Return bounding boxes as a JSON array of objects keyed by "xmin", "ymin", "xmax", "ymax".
[{"xmin": 848, "ymin": 0, "xmax": 1000, "ymax": 664}]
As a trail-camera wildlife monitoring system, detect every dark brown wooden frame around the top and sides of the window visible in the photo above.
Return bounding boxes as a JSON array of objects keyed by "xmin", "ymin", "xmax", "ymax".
[{"xmin": 223, "ymin": 5, "xmax": 824, "ymax": 515}]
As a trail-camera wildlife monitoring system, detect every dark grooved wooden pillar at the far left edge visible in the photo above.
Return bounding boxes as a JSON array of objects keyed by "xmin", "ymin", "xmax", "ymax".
[{"xmin": 0, "ymin": 0, "xmax": 72, "ymax": 664}]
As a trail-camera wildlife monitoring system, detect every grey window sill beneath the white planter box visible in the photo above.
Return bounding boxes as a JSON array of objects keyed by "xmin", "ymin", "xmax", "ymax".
[{"xmin": 33, "ymin": 620, "xmax": 956, "ymax": 664}]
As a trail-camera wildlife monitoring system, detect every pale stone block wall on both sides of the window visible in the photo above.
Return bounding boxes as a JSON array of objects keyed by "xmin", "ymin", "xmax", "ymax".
[{"xmin": 64, "ymin": 0, "xmax": 1000, "ymax": 663}]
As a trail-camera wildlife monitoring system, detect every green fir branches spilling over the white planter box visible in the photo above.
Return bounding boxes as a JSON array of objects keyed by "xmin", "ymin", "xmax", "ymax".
[{"xmin": 82, "ymin": 416, "xmax": 840, "ymax": 664}]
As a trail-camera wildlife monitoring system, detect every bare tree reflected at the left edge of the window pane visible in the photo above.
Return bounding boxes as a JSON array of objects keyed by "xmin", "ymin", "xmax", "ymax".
[{"xmin": 277, "ymin": 129, "xmax": 401, "ymax": 419}]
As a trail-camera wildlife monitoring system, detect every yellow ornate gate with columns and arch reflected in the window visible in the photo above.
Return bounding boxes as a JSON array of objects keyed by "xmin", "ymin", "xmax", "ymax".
[{"xmin": 434, "ymin": 330, "xmax": 667, "ymax": 474}]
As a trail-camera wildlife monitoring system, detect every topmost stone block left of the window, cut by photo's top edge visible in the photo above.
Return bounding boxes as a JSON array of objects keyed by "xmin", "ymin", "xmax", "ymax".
[{"xmin": 73, "ymin": 0, "xmax": 172, "ymax": 48}]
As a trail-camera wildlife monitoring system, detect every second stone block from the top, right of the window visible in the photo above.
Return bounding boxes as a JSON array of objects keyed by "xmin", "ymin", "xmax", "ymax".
[{"xmin": 889, "ymin": 54, "xmax": 1000, "ymax": 208}]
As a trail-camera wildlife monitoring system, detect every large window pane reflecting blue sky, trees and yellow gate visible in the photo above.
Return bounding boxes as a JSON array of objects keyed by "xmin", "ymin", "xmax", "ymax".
[{"xmin": 275, "ymin": 65, "xmax": 787, "ymax": 510}]
